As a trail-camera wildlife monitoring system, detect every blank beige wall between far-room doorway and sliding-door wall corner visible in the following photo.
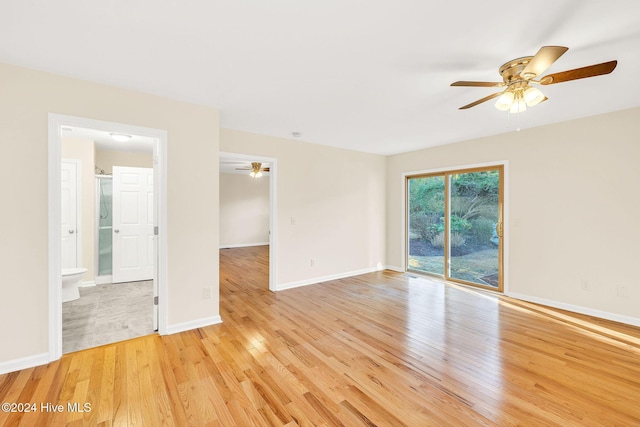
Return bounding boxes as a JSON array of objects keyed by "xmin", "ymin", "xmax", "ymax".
[{"xmin": 220, "ymin": 129, "xmax": 385, "ymax": 287}]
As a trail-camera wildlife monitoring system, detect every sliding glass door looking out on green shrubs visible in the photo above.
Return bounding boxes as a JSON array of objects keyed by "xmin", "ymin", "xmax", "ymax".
[{"xmin": 406, "ymin": 166, "xmax": 503, "ymax": 291}]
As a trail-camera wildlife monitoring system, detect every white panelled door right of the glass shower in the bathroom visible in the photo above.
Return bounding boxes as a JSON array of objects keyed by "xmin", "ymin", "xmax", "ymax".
[{"xmin": 112, "ymin": 166, "xmax": 155, "ymax": 283}]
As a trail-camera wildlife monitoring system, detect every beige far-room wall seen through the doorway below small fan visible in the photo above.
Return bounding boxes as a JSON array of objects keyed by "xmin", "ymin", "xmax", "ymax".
[{"xmin": 220, "ymin": 173, "xmax": 269, "ymax": 248}]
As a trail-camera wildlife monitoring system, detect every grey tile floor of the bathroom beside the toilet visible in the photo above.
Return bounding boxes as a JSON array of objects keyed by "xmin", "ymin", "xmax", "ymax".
[{"xmin": 62, "ymin": 280, "xmax": 154, "ymax": 353}]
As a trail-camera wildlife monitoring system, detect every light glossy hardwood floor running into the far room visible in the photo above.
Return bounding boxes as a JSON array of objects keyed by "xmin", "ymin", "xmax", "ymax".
[{"xmin": 0, "ymin": 247, "xmax": 640, "ymax": 426}]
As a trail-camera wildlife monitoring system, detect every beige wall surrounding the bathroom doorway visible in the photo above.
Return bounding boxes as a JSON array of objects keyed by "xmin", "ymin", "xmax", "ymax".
[{"xmin": 0, "ymin": 64, "xmax": 219, "ymax": 363}]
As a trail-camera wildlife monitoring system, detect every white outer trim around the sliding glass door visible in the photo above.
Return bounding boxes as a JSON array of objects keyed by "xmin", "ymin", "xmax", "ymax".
[{"xmin": 400, "ymin": 160, "xmax": 510, "ymax": 294}]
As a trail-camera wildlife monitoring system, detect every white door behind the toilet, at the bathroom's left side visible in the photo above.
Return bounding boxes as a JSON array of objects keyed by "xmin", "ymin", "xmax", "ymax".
[{"xmin": 60, "ymin": 160, "xmax": 80, "ymax": 268}]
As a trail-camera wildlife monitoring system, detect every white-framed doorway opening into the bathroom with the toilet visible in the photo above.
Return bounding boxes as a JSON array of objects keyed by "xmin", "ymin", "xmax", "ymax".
[{"xmin": 49, "ymin": 114, "xmax": 167, "ymax": 360}]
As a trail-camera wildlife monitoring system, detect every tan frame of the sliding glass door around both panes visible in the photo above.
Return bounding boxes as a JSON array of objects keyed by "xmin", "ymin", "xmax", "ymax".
[{"xmin": 402, "ymin": 161, "xmax": 509, "ymax": 293}]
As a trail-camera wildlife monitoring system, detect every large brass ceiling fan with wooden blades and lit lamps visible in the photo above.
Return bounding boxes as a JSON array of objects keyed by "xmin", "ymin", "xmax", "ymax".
[{"xmin": 451, "ymin": 46, "xmax": 618, "ymax": 113}]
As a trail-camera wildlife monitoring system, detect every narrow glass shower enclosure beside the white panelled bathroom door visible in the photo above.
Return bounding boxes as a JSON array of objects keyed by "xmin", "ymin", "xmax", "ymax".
[{"xmin": 96, "ymin": 175, "xmax": 113, "ymax": 283}]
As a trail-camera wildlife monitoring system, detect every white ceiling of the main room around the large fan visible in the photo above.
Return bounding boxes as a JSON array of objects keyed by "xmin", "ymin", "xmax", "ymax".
[{"xmin": 0, "ymin": 0, "xmax": 640, "ymax": 154}]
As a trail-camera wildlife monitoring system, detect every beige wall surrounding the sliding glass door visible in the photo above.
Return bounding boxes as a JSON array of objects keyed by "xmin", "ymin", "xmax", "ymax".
[{"xmin": 386, "ymin": 108, "xmax": 640, "ymax": 322}]
